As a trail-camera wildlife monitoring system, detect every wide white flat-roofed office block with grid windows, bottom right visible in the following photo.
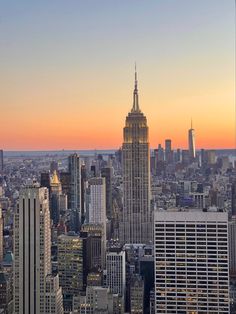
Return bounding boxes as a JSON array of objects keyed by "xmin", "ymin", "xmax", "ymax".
[{"xmin": 154, "ymin": 209, "xmax": 229, "ymax": 314}]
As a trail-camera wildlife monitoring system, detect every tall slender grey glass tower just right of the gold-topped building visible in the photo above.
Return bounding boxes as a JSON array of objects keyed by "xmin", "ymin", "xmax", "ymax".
[{"xmin": 68, "ymin": 154, "xmax": 81, "ymax": 232}]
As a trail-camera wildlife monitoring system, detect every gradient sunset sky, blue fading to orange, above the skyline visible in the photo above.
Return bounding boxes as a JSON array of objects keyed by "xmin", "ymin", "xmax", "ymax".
[{"xmin": 0, "ymin": 0, "xmax": 235, "ymax": 150}]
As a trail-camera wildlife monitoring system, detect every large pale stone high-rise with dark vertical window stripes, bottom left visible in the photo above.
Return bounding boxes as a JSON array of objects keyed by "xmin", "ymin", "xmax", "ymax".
[{"xmin": 13, "ymin": 186, "xmax": 63, "ymax": 314}]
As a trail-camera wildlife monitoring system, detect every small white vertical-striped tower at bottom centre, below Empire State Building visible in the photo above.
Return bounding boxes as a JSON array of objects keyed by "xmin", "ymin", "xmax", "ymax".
[{"xmin": 106, "ymin": 249, "xmax": 126, "ymax": 297}]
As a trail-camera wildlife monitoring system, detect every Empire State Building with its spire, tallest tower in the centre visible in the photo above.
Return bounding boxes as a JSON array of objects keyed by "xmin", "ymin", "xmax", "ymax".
[{"xmin": 120, "ymin": 70, "xmax": 152, "ymax": 244}]
